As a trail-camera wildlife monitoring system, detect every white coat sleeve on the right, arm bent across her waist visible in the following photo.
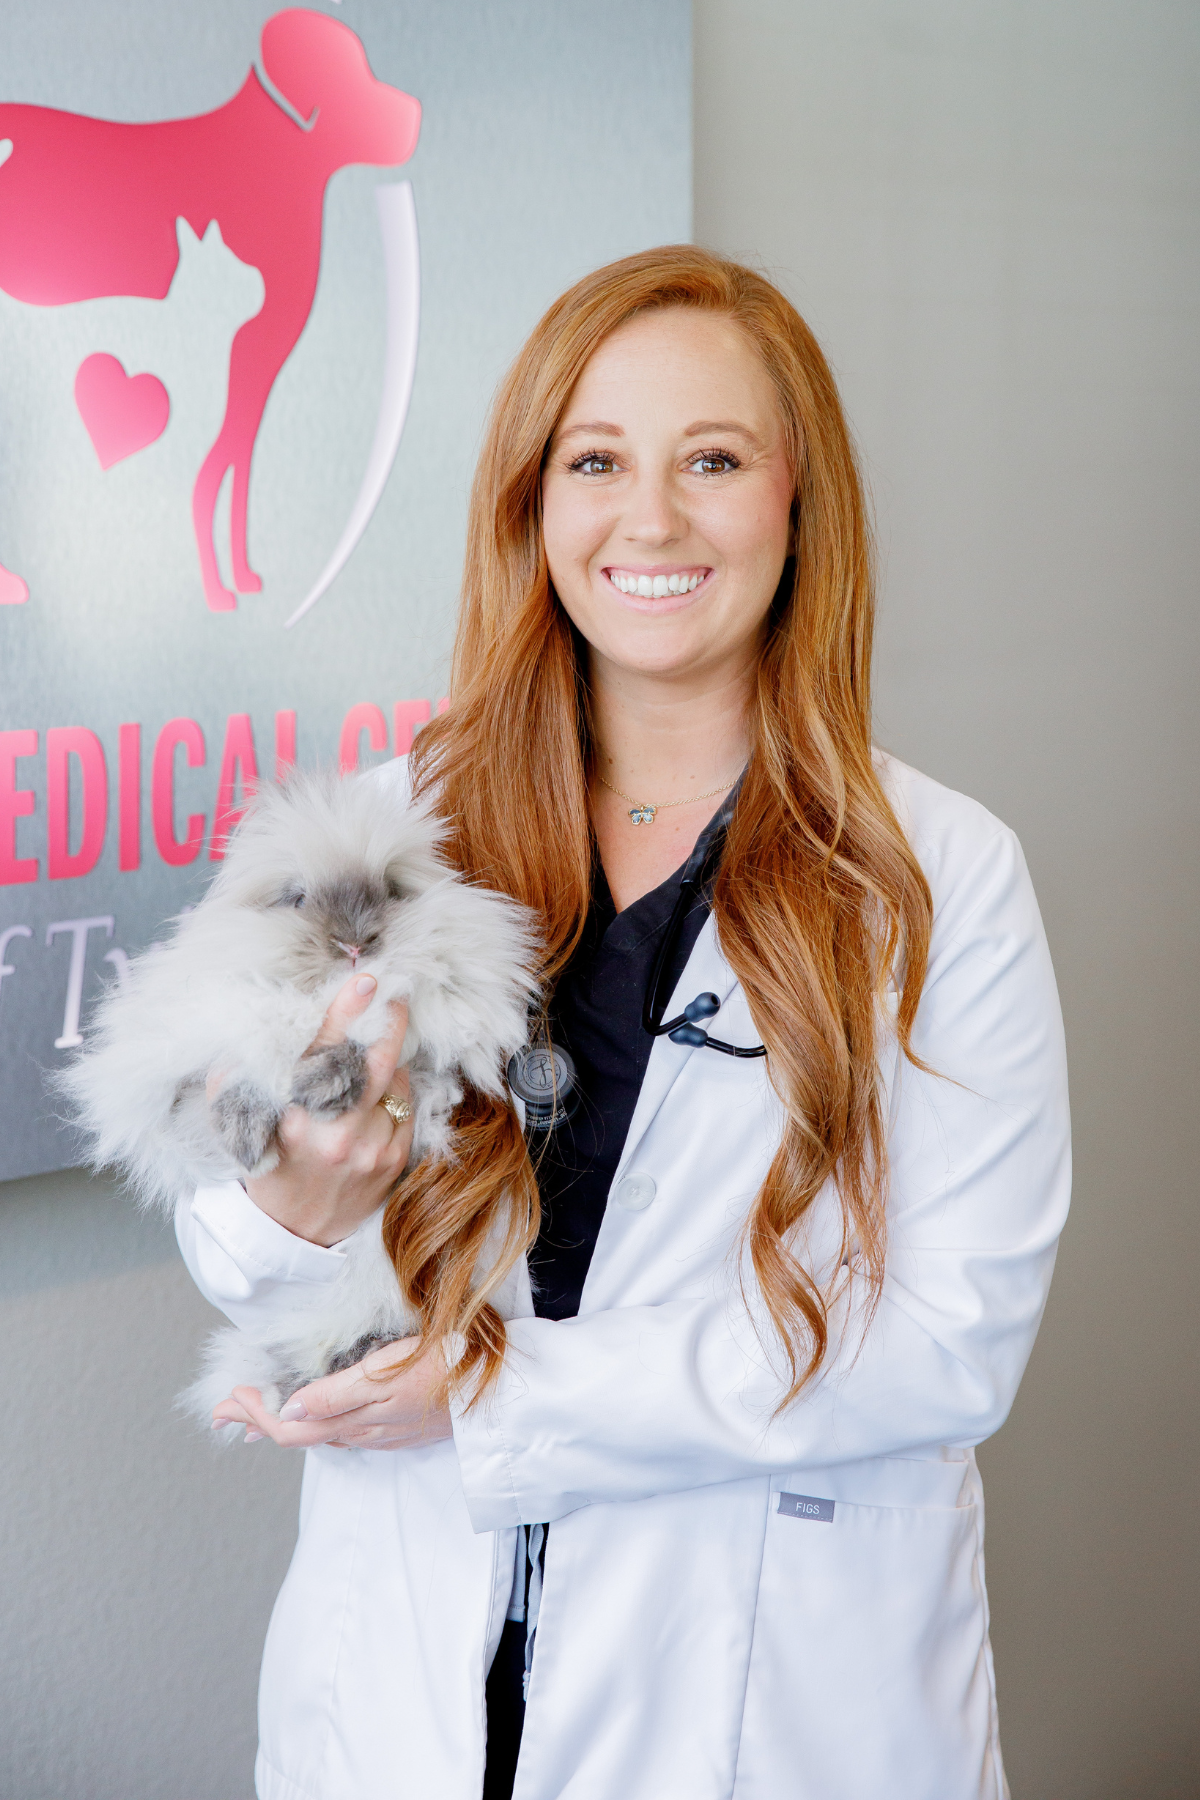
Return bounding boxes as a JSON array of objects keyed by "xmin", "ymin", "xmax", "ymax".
[{"xmin": 455, "ymin": 821, "xmax": 1070, "ymax": 1530}]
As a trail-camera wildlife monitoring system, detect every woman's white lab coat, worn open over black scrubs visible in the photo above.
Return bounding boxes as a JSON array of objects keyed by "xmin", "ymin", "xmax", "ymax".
[{"xmin": 178, "ymin": 758, "xmax": 1070, "ymax": 1800}]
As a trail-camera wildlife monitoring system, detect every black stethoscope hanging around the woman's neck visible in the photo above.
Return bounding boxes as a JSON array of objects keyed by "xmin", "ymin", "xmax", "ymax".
[{"xmin": 507, "ymin": 806, "xmax": 766, "ymax": 1130}]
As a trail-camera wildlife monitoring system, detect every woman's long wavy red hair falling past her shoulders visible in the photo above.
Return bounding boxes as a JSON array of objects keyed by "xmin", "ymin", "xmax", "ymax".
[{"xmin": 387, "ymin": 245, "xmax": 932, "ymax": 1404}]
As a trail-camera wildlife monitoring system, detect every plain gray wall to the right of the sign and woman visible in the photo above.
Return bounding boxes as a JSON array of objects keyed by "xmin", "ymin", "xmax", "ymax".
[{"xmin": 694, "ymin": 0, "xmax": 1200, "ymax": 1800}]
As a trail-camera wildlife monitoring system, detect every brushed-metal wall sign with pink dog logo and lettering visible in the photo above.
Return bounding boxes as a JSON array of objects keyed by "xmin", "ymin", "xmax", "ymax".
[{"xmin": 0, "ymin": 0, "xmax": 691, "ymax": 1179}]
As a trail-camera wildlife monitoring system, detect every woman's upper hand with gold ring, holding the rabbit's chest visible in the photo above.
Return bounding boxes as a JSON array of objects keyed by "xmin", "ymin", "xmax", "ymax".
[{"xmin": 237, "ymin": 976, "xmax": 412, "ymax": 1246}]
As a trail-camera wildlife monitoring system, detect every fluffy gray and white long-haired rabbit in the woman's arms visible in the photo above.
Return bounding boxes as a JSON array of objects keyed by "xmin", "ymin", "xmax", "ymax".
[{"xmin": 61, "ymin": 774, "xmax": 536, "ymax": 1417}]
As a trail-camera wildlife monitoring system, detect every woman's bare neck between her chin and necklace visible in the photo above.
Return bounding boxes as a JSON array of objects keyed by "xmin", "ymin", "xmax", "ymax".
[{"xmin": 590, "ymin": 655, "xmax": 754, "ymax": 805}]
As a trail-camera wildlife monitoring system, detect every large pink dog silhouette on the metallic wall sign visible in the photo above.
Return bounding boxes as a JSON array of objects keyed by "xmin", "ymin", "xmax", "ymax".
[{"xmin": 0, "ymin": 7, "xmax": 421, "ymax": 612}]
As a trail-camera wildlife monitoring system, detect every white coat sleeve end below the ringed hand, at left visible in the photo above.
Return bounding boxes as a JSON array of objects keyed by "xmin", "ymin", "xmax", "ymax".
[{"xmin": 175, "ymin": 1181, "xmax": 345, "ymax": 1330}]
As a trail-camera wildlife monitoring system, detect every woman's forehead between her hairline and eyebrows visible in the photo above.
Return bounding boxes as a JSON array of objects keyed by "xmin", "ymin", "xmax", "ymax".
[{"xmin": 558, "ymin": 306, "xmax": 783, "ymax": 437}]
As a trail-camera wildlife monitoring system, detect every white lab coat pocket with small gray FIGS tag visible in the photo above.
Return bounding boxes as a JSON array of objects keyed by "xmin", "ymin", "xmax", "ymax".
[{"xmin": 734, "ymin": 1460, "xmax": 1004, "ymax": 1800}]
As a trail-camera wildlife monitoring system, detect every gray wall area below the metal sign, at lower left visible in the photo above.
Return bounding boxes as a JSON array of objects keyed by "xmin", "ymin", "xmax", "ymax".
[{"xmin": 0, "ymin": 1174, "xmax": 300, "ymax": 1800}]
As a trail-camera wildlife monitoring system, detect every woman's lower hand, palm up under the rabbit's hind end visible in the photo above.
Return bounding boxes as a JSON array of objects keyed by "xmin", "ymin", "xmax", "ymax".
[{"xmin": 212, "ymin": 1337, "xmax": 450, "ymax": 1451}]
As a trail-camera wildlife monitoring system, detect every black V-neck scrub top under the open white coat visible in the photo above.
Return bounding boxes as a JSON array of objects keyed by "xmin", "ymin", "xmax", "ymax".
[{"xmin": 484, "ymin": 799, "xmax": 741, "ymax": 1800}]
